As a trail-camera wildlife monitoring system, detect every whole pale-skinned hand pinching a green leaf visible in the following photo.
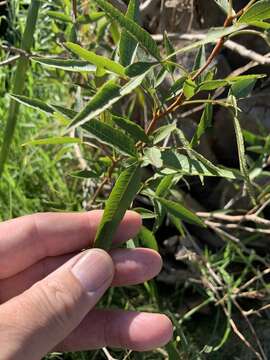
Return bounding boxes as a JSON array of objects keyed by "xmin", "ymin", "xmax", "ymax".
[{"xmin": 0, "ymin": 211, "xmax": 172, "ymax": 360}]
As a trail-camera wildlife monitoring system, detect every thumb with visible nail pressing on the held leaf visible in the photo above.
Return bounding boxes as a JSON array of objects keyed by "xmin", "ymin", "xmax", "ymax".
[{"xmin": 0, "ymin": 249, "xmax": 114, "ymax": 360}]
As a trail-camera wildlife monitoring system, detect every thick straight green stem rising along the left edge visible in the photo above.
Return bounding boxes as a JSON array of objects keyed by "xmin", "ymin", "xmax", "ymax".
[{"xmin": 0, "ymin": 0, "xmax": 40, "ymax": 176}]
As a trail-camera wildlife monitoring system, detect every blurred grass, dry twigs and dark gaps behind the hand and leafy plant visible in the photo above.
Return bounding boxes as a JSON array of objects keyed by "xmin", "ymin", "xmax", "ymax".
[{"xmin": 0, "ymin": 0, "xmax": 270, "ymax": 360}]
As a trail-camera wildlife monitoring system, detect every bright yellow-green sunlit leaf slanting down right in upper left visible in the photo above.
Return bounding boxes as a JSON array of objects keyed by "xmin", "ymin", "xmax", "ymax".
[{"xmin": 65, "ymin": 42, "xmax": 125, "ymax": 76}]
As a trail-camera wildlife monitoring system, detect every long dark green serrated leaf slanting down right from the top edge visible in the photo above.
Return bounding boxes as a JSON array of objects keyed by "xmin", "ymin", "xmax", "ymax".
[{"xmin": 94, "ymin": 0, "xmax": 161, "ymax": 60}]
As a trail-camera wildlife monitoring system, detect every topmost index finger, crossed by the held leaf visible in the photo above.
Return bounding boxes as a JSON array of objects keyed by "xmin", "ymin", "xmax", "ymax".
[{"xmin": 0, "ymin": 210, "xmax": 141, "ymax": 279}]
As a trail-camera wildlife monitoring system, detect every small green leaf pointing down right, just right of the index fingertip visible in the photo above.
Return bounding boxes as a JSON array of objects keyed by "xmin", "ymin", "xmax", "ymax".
[{"xmin": 157, "ymin": 197, "xmax": 205, "ymax": 227}]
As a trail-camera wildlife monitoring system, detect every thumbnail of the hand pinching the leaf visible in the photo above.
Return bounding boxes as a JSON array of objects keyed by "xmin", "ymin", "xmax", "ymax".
[{"xmin": 71, "ymin": 249, "xmax": 114, "ymax": 293}]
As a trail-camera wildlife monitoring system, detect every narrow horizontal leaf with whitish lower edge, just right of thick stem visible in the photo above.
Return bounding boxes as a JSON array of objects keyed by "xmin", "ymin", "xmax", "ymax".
[{"xmin": 31, "ymin": 57, "xmax": 97, "ymax": 72}]
